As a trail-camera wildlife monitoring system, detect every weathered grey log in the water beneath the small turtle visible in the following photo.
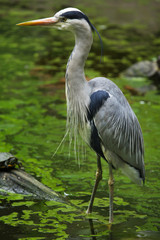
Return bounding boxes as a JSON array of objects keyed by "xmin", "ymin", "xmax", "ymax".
[{"xmin": 0, "ymin": 169, "xmax": 67, "ymax": 203}]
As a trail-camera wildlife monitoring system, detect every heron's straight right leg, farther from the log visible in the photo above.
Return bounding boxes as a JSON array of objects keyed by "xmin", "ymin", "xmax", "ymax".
[{"xmin": 108, "ymin": 163, "xmax": 114, "ymax": 223}]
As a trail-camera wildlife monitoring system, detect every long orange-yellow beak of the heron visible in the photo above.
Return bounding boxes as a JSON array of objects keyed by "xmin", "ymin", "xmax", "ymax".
[{"xmin": 16, "ymin": 17, "xmax": 58, "ymax": 26}]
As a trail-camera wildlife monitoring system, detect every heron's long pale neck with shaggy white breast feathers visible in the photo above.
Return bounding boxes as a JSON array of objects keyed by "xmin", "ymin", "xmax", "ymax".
[{"xmin": 66, "ymin": 26, "xmax": 93, "ymax": 138}]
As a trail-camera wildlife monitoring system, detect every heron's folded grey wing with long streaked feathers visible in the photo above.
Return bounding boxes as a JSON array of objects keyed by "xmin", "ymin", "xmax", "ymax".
[{"xmin": 91, "ymin": 79, "xmax": 144, "ymax": 179}]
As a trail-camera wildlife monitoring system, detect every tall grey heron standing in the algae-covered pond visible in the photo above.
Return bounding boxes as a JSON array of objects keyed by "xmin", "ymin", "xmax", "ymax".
[{"xmin": 18, "ymin": 7, "xmax": 145, "ymax": 223}]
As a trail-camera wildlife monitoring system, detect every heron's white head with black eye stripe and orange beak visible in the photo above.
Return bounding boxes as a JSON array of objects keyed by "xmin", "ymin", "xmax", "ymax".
[{"xmin": 17, "ymin": 8, "xmax": 94, "ymax": 31}]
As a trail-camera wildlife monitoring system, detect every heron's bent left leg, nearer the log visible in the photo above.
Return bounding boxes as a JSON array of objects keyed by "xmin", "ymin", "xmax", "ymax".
[{"xmin": 86, "ymin": 155, "xmax": 102, "ymax": 213}]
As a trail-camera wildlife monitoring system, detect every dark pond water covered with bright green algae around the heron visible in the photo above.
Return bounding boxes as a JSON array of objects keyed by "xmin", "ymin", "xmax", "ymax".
[{"xmin": 0, "ymin": 0, "xmax": 160, "ymax": 240}]
